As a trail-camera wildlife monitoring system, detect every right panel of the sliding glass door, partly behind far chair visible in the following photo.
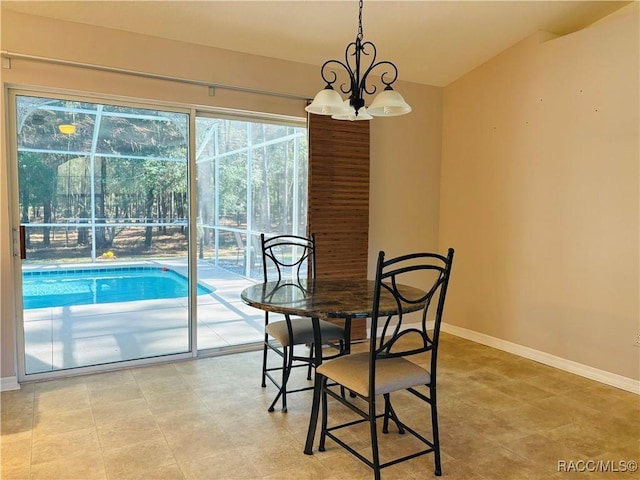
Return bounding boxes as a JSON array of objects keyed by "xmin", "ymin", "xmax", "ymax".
[{"xmin": 195, "ymin": 114, "xmax": 308, "ymax": 350}]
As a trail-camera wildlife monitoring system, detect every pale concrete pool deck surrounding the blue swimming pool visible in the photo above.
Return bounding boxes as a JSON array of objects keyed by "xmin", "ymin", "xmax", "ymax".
[{"xmin": 24, "ymin": 260, "xmax": 274, "ymax": 374}]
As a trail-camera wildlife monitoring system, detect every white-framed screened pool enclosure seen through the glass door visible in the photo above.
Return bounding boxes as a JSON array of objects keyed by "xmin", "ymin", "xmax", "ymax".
[{"xmin": 16, "ymin": 96, "xmax": 307, "ymax": 276}]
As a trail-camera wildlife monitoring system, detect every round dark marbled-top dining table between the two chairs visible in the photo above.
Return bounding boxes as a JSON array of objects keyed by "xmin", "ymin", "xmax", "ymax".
[{"xmin": 240, "ymin": 278, "xmax": 424, "ymax": 455}]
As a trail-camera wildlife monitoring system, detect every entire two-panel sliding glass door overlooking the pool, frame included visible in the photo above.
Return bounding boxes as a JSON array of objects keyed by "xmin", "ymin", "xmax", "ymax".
[{"xmin": 10, "ymin": 90, "xmax": 308, "ymax": 380}]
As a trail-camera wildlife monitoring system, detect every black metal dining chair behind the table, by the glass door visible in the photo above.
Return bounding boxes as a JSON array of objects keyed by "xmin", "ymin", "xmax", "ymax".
[{"xmin": 260, "ymin": 233, "xmax": 349, "ymax": 412}]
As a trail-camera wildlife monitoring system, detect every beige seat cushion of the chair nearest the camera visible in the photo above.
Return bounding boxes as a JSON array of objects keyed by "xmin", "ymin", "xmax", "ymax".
[{"xmin": 317, "ymin": 352, "xmax": 431, "ymax": 397}]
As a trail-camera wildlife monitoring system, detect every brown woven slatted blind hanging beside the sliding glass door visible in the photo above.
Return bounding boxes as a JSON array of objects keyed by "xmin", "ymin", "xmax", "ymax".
[{"xmin": 308, "ymin": 115, "xmax": 369, "ymax": 339}]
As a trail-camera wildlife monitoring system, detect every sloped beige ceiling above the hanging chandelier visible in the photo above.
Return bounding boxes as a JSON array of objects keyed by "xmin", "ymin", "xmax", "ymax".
[{"xmin": 0, "ymin": 0, "xmax": 630, "ymax": 86}]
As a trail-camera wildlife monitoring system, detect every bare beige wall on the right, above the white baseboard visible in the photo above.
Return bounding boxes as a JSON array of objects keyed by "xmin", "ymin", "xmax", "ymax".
[{"xmin": 440, "ymin": 3, "xmax": 640, "ymax": 380}]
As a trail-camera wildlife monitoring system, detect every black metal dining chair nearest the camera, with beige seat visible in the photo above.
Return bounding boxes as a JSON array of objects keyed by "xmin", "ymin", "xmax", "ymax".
[{"xmin": 317, "ymin": 249, "xmax": 454, "ymax": 479}]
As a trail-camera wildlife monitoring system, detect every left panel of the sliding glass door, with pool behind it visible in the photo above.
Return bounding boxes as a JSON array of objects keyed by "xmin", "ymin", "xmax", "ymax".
[{"xmin": 12, "ymin": 94, "xmax": 191, "ymax": 377}]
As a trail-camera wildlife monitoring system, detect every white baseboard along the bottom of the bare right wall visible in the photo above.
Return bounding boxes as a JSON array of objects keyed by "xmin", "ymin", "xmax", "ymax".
[{"xmin": 441, "ymin": 323, "xmax": 640, "ymax": 395}]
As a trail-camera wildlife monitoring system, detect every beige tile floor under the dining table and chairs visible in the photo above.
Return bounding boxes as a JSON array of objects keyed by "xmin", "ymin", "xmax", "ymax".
[{"xmin": 1, "ymin": 334, "xmax": 640, "ymax": 480}]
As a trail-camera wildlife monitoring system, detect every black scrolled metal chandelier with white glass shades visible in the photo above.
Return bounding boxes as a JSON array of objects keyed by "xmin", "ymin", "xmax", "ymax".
[{"xmin": 305, "ymin": 0, "xmax": 411, "ymax": 120}]
